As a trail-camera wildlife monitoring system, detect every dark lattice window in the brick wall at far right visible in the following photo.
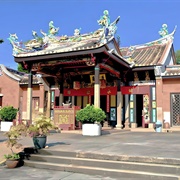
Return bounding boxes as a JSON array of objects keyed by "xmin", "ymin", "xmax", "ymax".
[{"xmin": 171, "ymin": 94, "xmax": 180, "ymax": 126}]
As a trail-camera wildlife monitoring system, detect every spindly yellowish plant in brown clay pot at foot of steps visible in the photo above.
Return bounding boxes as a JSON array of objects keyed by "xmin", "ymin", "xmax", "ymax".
[{"xmin": 4, "ymin": 124, "xmax": 26, "ymax": 168}]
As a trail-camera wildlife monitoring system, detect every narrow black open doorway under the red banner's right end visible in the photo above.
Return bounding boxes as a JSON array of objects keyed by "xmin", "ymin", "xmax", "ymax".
[{"xmin": 136, "ymin": 94, "xmax": 143, "ymax": 127}]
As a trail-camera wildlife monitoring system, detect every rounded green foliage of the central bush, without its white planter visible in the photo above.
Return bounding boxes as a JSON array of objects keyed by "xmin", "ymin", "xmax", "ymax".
[{"xmin": 76, "ymin": 104, "xmax": 106, "ymax": 124}]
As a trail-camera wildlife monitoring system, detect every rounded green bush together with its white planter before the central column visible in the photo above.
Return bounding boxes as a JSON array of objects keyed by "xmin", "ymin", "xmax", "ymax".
[{"xmin": 76, "ymin": 104, "xmax": 106, "ymax": 136}]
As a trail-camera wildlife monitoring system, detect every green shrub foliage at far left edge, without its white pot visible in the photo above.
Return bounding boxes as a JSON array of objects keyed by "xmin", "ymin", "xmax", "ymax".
[{"xmin": 0, "ymin": 106, "xmax": 18, "ymax": 121}]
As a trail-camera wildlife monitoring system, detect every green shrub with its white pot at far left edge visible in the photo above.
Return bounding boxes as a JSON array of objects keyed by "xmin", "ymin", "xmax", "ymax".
[{"xmin": 0, "ymin": 106, "xmax": 18, "ymax": 131}]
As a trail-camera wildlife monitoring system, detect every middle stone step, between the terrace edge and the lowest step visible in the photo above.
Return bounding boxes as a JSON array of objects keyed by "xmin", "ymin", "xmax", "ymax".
[{"xmin": 30, "ymin": 155, "xmax": 180, "ymax": 176}]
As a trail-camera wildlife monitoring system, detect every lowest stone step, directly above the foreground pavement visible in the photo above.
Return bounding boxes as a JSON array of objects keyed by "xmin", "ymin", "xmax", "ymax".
[{"xmin": 25, "ymin": 160, "xmax": 179, "ymax": 180}]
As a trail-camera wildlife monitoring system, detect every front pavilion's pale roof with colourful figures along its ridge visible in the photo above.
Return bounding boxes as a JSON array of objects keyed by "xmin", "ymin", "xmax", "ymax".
[{"xmin": 8, "ymin": 10, "xmax": 120, "ymax": 57}]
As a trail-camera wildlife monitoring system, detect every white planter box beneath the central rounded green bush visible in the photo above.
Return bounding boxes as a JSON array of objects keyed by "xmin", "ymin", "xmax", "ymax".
[{"xmin": 82, "ymin": 124, "xmax": 102, "ymax": 136}]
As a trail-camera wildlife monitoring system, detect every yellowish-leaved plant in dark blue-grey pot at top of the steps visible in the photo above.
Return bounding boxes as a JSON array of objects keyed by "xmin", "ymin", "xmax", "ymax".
[{"xmin": 27, "ymin": 114, "xmax": 55, "ymax": 149}]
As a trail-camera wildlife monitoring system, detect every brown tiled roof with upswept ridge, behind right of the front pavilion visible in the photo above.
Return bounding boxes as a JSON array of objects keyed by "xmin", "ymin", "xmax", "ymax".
[{"xmin": 120, "ymin": 25, "xmax": 176, "ymax": 66}]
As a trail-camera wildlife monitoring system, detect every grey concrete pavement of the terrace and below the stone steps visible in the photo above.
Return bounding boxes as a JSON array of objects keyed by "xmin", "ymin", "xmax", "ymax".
[{"xmin": 0, "ymin": 130, "xmax": 180, "ymax": 180}]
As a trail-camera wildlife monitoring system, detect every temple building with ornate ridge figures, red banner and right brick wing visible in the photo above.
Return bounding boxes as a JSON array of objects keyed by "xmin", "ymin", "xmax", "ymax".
[{"xmin": 9, "ymin": 10, "xmax": 180, "ymax": 130}]
